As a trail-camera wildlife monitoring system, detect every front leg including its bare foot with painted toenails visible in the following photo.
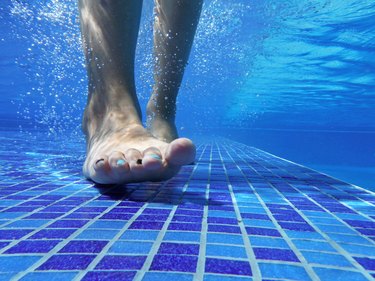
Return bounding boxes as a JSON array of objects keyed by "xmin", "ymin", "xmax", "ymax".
[{"xmin": 79, "ymin": 0, "xmax": 195, "ymax": 183}]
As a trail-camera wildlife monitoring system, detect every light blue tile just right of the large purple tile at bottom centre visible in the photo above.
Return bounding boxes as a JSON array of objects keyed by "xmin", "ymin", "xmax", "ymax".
[{"xmin": 259, "ymin": 263, "xmax": 311, "ymax": 280}]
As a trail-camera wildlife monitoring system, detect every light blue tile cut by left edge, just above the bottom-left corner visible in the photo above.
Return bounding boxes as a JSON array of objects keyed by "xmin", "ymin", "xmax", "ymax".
[{"xmin": 0, "ymin": 256, "xmax": 41, "ymax": 273}]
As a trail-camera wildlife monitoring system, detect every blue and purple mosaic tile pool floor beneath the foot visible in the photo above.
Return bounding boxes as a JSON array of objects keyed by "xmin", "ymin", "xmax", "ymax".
[{"xmin": 0, "ymin": 134, "xmax": 375, "ymax": 281}]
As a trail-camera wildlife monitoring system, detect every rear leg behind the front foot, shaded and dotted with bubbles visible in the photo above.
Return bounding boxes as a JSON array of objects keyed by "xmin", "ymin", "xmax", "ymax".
[{"xmin": 147, "ymin": 0, "xmax": 203, "ymax": 142}]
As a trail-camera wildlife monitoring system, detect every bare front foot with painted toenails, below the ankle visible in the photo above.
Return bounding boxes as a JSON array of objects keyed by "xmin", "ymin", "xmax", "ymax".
[{"xmin": 83, "ymin": 114, "xmax": 195, "ymax": 184}]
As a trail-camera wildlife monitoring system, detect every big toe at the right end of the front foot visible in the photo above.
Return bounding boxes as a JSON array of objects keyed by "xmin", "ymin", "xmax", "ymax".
[{"xmin": 165, "ymin": 138, "xmax": 196, "ymax": 166}]
